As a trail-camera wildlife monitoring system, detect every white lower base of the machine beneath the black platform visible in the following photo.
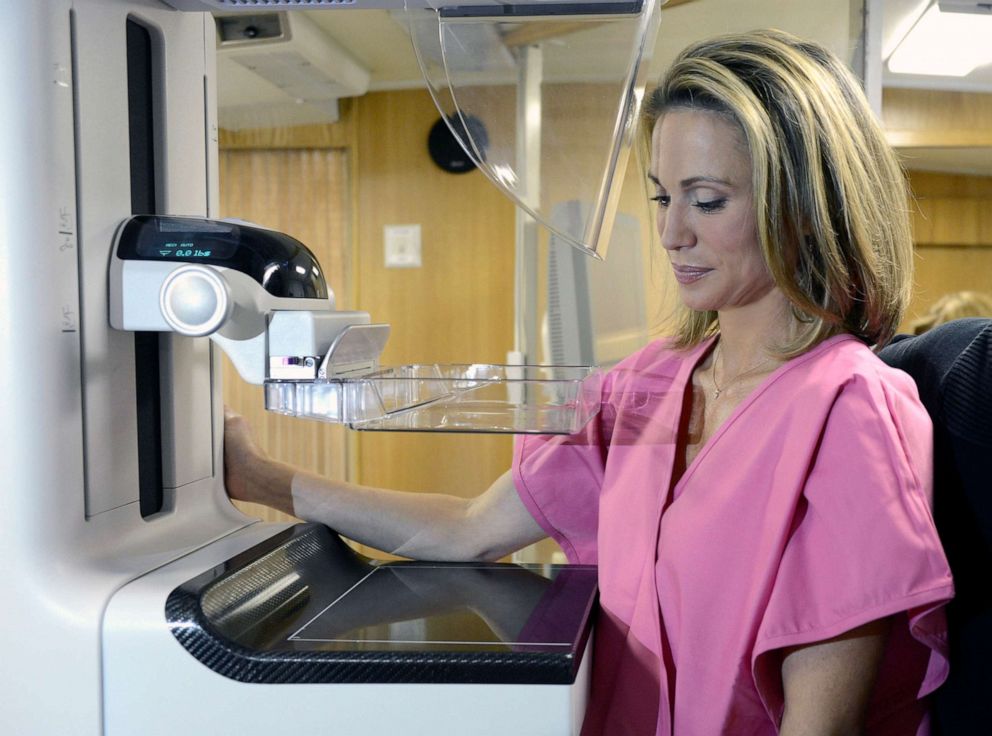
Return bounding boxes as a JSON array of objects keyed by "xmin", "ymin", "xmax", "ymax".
[{"xmin": 103, "ymin": 524, "xmax": 592, "ymax": 736}]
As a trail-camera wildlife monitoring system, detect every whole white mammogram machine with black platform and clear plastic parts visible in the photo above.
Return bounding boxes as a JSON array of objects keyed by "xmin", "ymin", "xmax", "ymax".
[{"xmin": 0, "ymin": 0, "xmax": 657, "ymax": 736}]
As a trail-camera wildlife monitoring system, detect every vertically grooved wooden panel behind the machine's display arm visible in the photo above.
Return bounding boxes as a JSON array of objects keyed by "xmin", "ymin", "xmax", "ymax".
[{"xmin": 220, "ymin": 150, "xmax": 351, "ymax": 521}]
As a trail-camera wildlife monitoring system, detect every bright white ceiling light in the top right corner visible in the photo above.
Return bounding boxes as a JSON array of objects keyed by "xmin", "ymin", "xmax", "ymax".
[{"xmin": 889, "ymin": 3, "xmax": 992, "ymax": 77}]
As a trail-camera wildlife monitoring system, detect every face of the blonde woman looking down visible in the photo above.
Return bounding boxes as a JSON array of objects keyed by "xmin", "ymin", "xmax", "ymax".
[{"xmin": 649, "ymin": 109, "xmax": 775, "ymax": 312}]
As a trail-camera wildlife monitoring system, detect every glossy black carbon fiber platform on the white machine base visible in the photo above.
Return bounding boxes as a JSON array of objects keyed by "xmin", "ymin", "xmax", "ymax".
[{"xmin": 165, "ymin": 524, "xmax": 597, "ymax": 684}]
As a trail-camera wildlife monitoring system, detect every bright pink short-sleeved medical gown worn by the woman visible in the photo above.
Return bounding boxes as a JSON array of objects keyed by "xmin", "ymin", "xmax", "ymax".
[{"xmin": 513, "ymin": 335, "xmax": 953, "ymax": 736}]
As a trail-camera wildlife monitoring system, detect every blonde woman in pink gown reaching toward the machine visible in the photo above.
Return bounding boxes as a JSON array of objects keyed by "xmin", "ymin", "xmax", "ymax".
[{"xmin": 227, "ymin": 31, "xmax": 952, "ymax": 736}]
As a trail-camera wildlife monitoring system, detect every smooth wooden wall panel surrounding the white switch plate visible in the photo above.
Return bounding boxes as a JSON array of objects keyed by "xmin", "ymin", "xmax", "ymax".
[{"xmin": 354, "ymin": 90, "xmax": 515, "ymax": 496}]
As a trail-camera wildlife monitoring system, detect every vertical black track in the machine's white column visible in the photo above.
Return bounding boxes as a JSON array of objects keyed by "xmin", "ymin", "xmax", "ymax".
[{"xmin": 127, "ymin": 19, "xmax": 163, "ymax": 517}]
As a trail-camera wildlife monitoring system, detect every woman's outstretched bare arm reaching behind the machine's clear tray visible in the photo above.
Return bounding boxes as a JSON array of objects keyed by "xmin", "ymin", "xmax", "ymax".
[{"xmin": 224, "ymin": 413, "xmax": 546, "ymax": 561}]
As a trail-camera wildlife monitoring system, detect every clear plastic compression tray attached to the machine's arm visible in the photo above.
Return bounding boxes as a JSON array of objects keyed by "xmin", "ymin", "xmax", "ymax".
[{"xmin": 265, "ymin": 364, "xmax": 602, "ymax": 434}]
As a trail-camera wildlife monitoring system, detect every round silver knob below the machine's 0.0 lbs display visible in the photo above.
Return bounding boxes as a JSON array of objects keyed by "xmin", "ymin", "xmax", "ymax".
[{"xmin": 159, "ymin": 264, "xmax": 233, "ymax": 337}]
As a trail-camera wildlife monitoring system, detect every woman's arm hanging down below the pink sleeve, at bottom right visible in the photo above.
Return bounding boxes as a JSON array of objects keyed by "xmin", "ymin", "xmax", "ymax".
[{"xmin": 779, "ymin": 619, "xmax": 889, "ymax": 736}]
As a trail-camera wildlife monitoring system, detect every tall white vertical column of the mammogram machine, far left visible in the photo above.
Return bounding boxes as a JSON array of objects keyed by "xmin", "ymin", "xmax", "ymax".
[{"xmin": 0, "ymin": 0, "xmax": 248, "ymax": 736}]
